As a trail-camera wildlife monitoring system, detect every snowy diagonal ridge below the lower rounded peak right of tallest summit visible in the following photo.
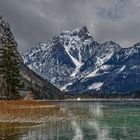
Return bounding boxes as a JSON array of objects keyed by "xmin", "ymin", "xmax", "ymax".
[{"xmin": 80, "ymin": 41, "xmax": 121, "ymax": 76}]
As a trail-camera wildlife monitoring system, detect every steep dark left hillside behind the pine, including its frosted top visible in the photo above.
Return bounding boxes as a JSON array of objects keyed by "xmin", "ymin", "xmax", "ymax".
[{"xmin": 0, "ymin": 16, "xmax": 64, "ymax": 99}]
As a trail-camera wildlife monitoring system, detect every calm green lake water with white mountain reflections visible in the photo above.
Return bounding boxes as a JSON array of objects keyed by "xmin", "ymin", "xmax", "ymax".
[{"xmin": 0, "ymin": 102, "xmax": 140, "ymax": 140}]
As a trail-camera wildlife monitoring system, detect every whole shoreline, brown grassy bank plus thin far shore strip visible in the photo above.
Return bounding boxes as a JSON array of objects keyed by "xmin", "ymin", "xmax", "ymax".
[{"xmin": 0, "ymin": 98, "xmax": 140, "ymax": 124}]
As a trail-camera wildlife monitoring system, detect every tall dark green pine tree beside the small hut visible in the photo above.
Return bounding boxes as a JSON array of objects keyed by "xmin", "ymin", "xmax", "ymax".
[{"xmin": 0, "ymin": 35, "xmax": 20, "ymax": 99}]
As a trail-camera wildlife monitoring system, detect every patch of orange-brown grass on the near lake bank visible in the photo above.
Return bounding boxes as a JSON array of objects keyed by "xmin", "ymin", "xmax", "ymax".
[{"xmin": 0, "ymin": 100, "xmax": 65, "ymax": 122}]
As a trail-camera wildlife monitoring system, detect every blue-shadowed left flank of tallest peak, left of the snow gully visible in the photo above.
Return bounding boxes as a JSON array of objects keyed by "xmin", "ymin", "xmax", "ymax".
[{"xmin": 23, "ymin": 40, "xmax": 75, "ymax": 87}]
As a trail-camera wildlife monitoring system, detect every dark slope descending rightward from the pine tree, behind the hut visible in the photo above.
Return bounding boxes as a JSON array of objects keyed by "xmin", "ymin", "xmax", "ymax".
[{"xmin": 20, "ymin": 63, "xmax": 65, "ymax": 100}]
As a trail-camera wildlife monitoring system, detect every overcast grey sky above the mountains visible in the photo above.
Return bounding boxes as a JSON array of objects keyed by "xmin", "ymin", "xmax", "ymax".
[{"xmin": 0, "ymin": 0, "xmax": 140, "ymax": 53}]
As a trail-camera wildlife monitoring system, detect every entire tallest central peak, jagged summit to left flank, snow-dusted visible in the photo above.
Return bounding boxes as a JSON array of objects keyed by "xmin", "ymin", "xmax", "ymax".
[{"xmin": 22, "ymin": 26, "xmax": 99, "ymax": 88}]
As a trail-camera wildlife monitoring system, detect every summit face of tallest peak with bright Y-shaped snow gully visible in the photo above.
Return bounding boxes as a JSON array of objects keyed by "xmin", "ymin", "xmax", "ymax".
[{"xmin": 59, "ymin": 26, "xmax": 99, "ymax": 77}]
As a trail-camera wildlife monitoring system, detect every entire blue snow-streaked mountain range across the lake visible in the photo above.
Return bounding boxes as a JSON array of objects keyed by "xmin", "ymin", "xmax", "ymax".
[{"xmin": 22, "ymin": 26, "xmax": 140, "ymax": 94}]
